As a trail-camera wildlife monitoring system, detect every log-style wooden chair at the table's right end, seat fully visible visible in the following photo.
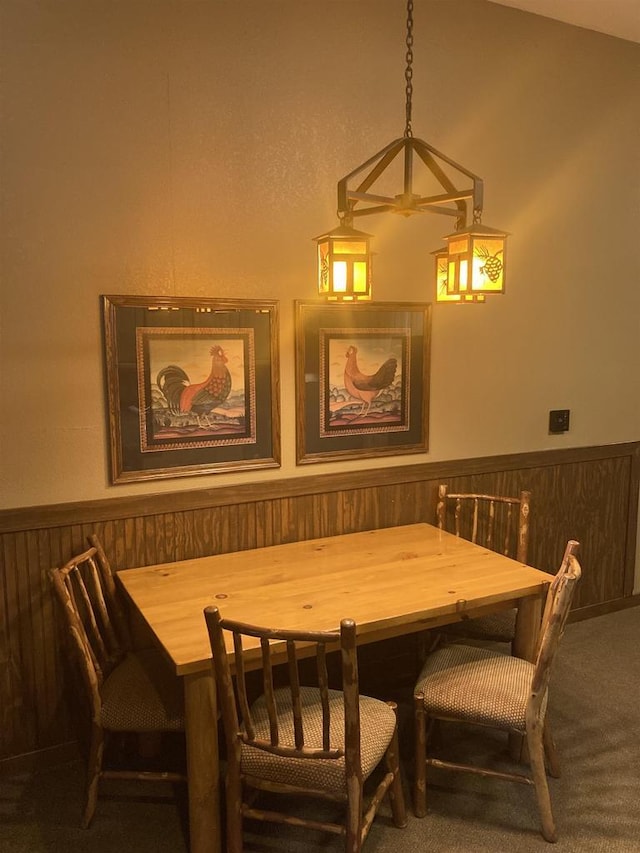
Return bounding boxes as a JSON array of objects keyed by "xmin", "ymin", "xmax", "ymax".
[{"xmin": 414, "ymin": 540, "xmax": 581, "ymax": 841}]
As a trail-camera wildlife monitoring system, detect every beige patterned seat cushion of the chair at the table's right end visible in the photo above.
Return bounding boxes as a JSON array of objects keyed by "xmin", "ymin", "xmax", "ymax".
[{"xmin": 414, "ymin": 644, "xmax": 547, "ymax": 732}]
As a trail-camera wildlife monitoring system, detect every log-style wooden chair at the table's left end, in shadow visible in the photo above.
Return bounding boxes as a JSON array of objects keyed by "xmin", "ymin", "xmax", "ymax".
[{"xmin": 49, "ymin": 536, "xmax": 186, "ymax": 828}]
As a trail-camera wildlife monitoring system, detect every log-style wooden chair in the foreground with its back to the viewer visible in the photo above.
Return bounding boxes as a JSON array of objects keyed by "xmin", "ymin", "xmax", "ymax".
[{"xmin": 204, "ymin": 607, "xmax": 406, "ymax": 853}]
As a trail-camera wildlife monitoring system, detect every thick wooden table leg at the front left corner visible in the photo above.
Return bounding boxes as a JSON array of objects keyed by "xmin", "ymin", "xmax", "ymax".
[{"xmin": 184, "ymin": 672, "xmax": 222, "ymax": 853}]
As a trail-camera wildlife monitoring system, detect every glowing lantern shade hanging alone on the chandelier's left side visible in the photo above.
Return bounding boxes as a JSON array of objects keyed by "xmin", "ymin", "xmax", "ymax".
[{"xmin": 314, "ymin": 225, "xmax": 372, "ymax": 302}]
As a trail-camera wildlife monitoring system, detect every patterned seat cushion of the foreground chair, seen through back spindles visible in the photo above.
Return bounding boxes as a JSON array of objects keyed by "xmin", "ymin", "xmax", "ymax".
[{"xmin": 241, "ymin": 687, "xmax": 396, "ymax": 791}]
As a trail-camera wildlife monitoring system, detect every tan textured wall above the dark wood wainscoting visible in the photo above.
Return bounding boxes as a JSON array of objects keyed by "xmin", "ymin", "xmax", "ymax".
[{"xmin": 0, "ymin": 0, "xmax": 640, "ymax": 508}]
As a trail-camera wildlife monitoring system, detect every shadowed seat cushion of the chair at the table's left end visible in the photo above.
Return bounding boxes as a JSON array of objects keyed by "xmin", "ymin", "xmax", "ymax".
[{"xmin": 101, "ymin": 649, "xmax": 184, "ymax": 732}]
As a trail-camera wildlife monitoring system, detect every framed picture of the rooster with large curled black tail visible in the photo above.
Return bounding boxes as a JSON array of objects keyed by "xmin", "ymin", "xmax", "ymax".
[{"xmin": 102, "ymin": 296, "xmax": 280, "ymax": 483}]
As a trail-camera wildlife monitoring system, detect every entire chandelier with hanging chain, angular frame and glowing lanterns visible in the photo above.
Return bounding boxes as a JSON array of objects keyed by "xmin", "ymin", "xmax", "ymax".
[{"xmin": 315, "ymin": 0, "xmax": 508, "ymax": 303}]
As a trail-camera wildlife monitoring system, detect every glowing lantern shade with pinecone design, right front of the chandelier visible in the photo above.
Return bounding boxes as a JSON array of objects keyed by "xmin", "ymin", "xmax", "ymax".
[{"xmin": 436, "ymin": 223, "xmax": 508, "ymax": 302}]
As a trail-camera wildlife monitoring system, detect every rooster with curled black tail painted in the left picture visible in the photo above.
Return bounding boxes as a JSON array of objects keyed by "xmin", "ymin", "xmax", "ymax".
[{"xmin": 156, "ymin": 345, "xmax": 231, "ymax": 426}]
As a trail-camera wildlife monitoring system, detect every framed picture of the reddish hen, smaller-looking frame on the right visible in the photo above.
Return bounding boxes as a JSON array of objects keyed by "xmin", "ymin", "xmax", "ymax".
[{"xmin": 296, "ymin": 302, "xmax": 431, "ymax": 465}]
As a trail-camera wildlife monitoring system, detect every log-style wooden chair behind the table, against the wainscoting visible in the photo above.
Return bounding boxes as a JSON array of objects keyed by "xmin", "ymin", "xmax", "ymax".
[{"xmin": 436, "ymin": 483, "xmax": 531, "ymax": 643}]
